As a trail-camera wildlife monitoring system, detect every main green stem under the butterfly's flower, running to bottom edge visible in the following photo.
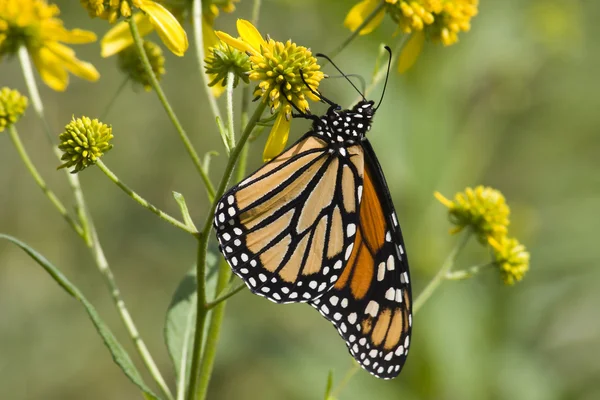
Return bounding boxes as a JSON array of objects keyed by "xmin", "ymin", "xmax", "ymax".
[{"xmin": 187, "ymin": 102, "xmax": 267, "ymax": 400}]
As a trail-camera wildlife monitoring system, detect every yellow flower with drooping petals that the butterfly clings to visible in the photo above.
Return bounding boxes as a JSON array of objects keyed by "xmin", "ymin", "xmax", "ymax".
[{"xmin": 216, "ymin": 19, "xmax": 324, "ymax": 161}]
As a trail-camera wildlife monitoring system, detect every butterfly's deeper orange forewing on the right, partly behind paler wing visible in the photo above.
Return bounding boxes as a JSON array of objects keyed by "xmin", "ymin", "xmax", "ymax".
[{"xmin": 310, "ymin": 140, "xmax": 412, "ymax": 379}]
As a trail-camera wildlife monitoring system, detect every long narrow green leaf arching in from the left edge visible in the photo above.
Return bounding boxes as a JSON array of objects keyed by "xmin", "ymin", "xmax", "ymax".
[{"xmin": 0, "ymin": 233, "xmax": 160, "ymax": 400}]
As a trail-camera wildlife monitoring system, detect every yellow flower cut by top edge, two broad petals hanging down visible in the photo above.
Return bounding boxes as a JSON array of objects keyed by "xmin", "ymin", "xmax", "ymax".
[{"xmin": 81, "ymin": 0, "xmax": 188, "ymax": 57}]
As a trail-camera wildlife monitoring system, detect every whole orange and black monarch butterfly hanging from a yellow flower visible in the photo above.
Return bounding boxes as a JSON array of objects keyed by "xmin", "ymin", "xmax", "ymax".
[{"xmin": 214, "ymin": 48, "xmax": 412, "ymax": 379}]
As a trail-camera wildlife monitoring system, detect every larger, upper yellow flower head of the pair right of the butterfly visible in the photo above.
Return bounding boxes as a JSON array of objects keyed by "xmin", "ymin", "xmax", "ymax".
[{"xmin": 434, "ymin": 186, "xmax": 510, "ymax": 243}]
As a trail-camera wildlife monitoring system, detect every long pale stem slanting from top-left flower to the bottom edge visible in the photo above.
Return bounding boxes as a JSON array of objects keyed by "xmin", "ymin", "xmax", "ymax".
[{"xmin": 19, "ymin": 47, "xmax": 173, "ymax": 400}]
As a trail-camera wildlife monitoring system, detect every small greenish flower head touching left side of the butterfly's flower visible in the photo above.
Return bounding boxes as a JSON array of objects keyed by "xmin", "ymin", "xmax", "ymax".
[{"xmin": 204, "ymin": 42, "xmax": 251, "ymax": 87}]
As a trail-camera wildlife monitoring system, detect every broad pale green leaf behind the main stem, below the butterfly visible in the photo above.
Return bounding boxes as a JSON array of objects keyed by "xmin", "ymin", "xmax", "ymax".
[{"xmin": 165, "ymin": 252, "xmax": 218, "ymax": 398}]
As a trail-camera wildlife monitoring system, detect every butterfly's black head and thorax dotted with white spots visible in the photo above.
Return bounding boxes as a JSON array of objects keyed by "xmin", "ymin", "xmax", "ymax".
[{"xmin": 313, "ymin": 100, "xmax": 375, "ymax": 144}]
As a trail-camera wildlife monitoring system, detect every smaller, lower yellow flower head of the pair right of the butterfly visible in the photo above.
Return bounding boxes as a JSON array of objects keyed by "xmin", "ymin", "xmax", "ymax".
[{"xmin": 489, "ymin": 237, "xmax": 530, "ymax": 285}]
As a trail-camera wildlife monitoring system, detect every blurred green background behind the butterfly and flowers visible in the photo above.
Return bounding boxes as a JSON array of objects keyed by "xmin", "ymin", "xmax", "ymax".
[{"xmin": 0, "ymin": 0, "xmax": 600, "ymax": 400}]
